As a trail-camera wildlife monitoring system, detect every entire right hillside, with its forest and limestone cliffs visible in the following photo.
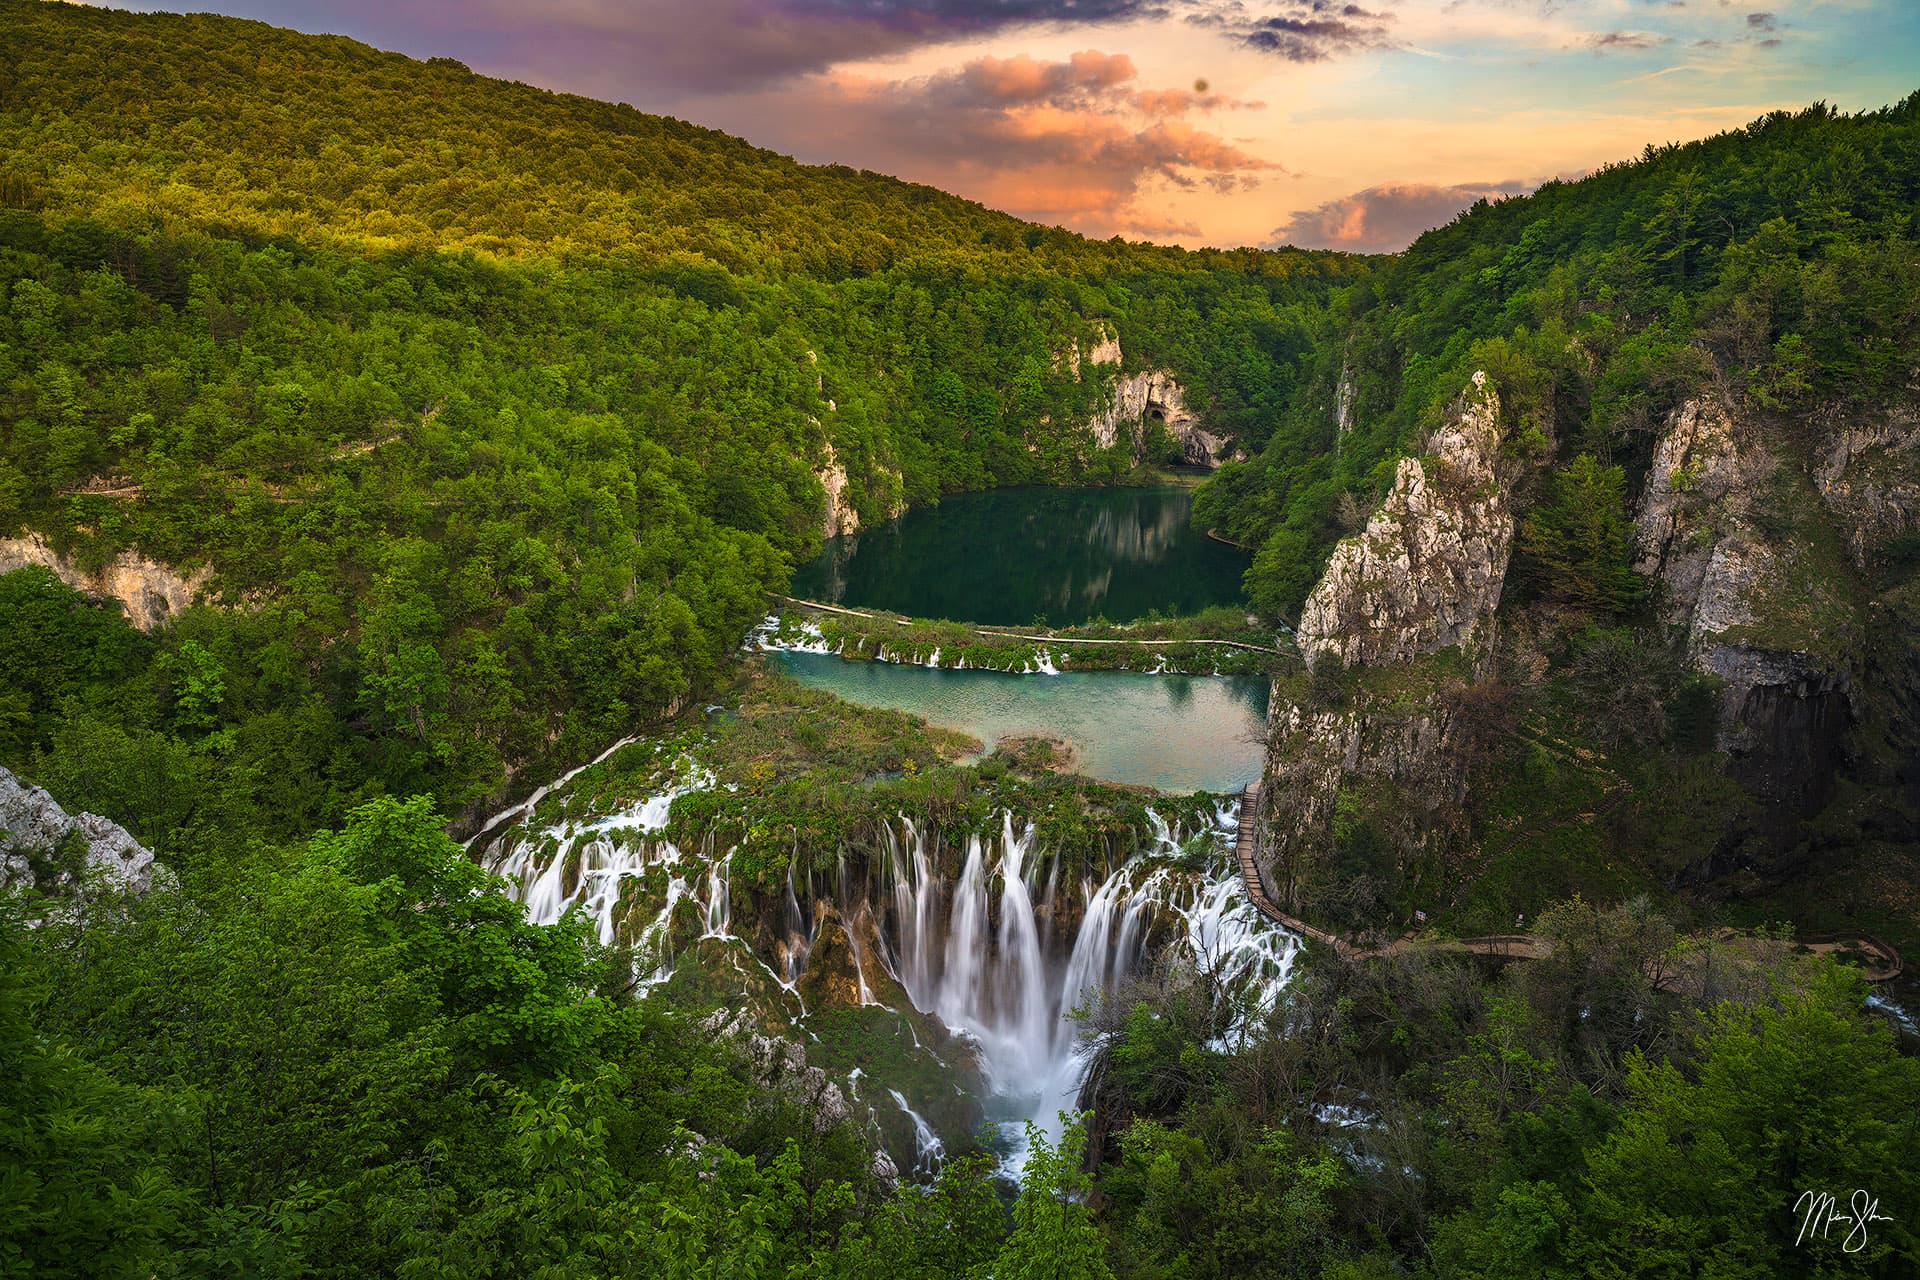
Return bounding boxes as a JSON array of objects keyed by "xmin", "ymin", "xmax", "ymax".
[{"xmin": 1196, "ymin": 94, "xmax": 1920, "ymax": 1013}]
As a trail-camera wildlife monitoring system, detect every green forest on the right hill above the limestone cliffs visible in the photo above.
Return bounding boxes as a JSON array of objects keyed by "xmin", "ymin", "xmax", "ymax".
[{"xmin": 1196, "ymin": 94, "xmax": 1920, "ymax": 614}]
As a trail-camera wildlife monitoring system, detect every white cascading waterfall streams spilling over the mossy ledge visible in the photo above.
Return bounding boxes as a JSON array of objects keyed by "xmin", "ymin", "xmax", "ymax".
[{"xmin": 490, "ymin": 766, "xmax": 1298, "ymax": 1169}]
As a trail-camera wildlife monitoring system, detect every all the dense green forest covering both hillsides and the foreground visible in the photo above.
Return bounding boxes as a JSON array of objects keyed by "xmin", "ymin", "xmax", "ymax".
[{"xmin": 0, "ymin": 0, "xmax": 1920, "ymax": 1280}]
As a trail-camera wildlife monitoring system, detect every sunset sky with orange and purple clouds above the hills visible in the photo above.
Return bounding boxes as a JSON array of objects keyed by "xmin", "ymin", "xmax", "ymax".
[{"xmin": 101, "ymin": 0, "xmax": 1920, "ymax": 251}]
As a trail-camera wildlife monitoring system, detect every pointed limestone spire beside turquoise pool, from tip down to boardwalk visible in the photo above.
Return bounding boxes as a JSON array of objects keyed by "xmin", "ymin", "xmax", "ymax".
[{"xmin": 1261, "ymin": 374, "xmax": 1513, "ymax": 921}]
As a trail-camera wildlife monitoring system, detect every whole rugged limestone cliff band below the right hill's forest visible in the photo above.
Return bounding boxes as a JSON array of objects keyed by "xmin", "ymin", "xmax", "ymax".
[{"xmin": 1261, "ymin": 376, "xmax": 1920, "ymax": 927}]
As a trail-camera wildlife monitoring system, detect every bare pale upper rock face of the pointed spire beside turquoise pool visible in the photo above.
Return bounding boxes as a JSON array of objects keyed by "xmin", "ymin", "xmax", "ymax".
[{"xmin": 1296, "ymin": 372, "xmax": 1513, "ymax": 666}]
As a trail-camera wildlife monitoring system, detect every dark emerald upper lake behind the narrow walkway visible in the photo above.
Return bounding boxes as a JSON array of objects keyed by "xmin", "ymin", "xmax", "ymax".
[{"xmin": 793, "ymin": 486, "xmax": 1246, "ymax": 626}]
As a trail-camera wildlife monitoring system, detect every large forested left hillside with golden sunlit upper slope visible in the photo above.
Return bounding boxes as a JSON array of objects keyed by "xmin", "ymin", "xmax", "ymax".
[{"xmin": 0, "ymin": 0, "xmax": 1365, "ymax": 839}]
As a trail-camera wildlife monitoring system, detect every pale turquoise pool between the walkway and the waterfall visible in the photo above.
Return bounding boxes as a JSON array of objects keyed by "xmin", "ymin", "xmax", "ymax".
[{"xmin": 768, "ymin": 652, "xmax": 1267, "ymax": 793}]
